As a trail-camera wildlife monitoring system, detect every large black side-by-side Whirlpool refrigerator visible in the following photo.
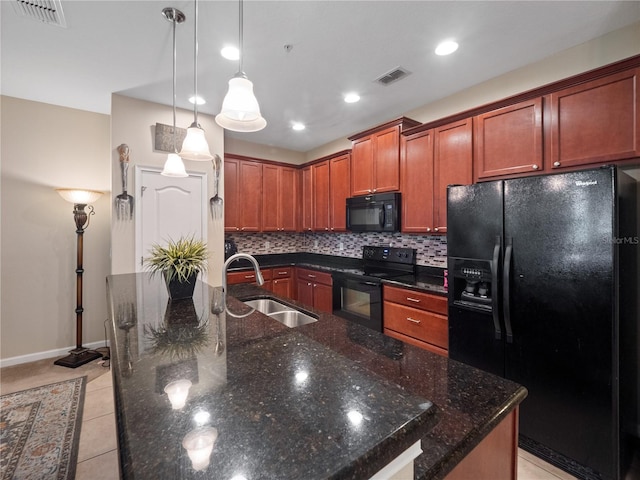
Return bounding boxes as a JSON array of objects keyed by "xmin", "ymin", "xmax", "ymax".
[{"xmin": 447, "ymin": 167, "xmax": 640, "ymax": 479}]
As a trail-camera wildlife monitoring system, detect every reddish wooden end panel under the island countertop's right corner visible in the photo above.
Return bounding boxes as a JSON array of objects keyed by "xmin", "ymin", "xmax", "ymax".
[{"xmin": 445, "ymin": 407, "xmax": 518, "ymax": 480}]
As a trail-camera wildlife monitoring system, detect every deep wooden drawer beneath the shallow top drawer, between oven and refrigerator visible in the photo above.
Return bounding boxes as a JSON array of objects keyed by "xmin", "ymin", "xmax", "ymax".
[{"xmin": 383, "ymin": 302, "xmax": 449, "ymax": 349}]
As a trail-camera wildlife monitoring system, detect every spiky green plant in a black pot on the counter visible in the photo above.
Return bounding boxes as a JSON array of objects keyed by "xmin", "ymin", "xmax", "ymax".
[{"xmin": 145, "ymin": 236, "xmax": 208, "ymax": 300}]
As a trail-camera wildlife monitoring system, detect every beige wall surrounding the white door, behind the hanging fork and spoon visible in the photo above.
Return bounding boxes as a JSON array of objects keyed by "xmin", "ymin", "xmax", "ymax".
[{"xmin": 111, "ymin": 95, "xmax": 224, "ymax": 285}]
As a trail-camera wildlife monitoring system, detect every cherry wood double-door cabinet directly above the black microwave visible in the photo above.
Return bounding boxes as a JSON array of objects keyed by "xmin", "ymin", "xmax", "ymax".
[{"xmin": 349, "ymin": 117, "xmax": 419, "ymax": 196}]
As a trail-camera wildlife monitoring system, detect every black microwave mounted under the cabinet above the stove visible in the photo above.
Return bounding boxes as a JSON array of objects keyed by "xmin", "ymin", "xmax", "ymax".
[{"xmin": 347, "ymin": 193, "xmax": 400, "ymax": 232}]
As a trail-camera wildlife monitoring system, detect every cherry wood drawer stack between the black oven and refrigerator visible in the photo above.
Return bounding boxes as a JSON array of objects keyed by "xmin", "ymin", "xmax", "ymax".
[{"xmin": 383, "ymin": 285, "xmax": 449, "ymax": 357}]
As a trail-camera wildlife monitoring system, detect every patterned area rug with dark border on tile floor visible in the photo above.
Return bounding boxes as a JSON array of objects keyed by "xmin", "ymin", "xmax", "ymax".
[{"xmin": 0, "ymin": 377, "xmax": 86, "ymax": 480}]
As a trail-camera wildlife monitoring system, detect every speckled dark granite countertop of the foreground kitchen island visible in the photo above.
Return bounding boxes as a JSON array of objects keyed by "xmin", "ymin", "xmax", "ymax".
[{"xmin": 107, "ymin": 274, "xmax": 526, "ymax": 480}]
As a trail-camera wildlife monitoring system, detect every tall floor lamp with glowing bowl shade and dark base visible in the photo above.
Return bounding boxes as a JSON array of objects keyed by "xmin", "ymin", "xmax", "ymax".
[{"xmin": 53, "ymin": 188, "xmax": 102, "ymax": 368}]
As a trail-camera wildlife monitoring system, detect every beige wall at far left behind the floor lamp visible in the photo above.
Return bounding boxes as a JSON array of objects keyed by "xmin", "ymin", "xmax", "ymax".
[{"xmin": 0, "ymin": 97, "xmax": 111, "ymax": 359}]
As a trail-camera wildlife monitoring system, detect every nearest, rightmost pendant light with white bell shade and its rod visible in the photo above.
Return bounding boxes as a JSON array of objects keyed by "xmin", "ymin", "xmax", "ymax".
[{"xmin": 216, "ymin": 0, "xmax": 267, "ymax": 132}]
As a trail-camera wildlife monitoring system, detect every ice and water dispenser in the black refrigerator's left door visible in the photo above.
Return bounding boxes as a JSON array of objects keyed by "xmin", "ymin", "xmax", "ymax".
[{"xmin": 449, "ymin": 257, "xmax": 497, "ymax": 313}]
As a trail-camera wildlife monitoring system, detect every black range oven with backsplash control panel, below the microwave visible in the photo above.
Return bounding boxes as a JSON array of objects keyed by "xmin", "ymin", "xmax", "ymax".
[{"xmin": 332, "ymin": 246, "xmax": 416, "ymax": 332}]
